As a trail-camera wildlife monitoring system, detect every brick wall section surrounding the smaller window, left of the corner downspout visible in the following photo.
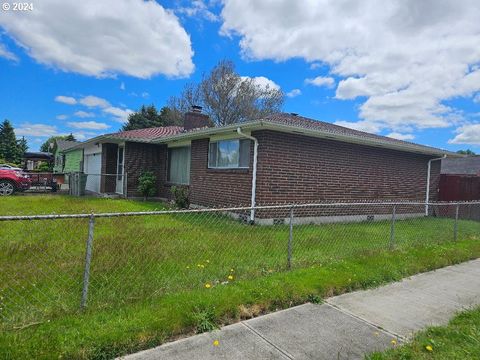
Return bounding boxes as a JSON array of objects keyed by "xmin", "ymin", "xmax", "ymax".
[{"xmin": 190, "ymin": 139, "xmax": 253, "ymax": 206}]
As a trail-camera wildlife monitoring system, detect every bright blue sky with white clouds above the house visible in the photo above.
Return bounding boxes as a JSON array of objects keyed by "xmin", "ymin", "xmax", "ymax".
[{"xmin": 0, "ymin": 0, "xmax": 480, "ymax": 153}]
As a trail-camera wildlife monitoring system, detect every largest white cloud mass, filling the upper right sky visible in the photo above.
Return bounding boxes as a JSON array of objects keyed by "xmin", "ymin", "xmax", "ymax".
[{"xmin": 221, "ymin": 0, "xmax": 480, "ymax": 133}]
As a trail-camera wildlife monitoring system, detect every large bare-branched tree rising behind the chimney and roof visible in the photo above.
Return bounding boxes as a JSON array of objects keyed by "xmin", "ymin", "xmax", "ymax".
[{"xmin": 168, "ymin": 60, "xmax": 284, "ymax": 126}]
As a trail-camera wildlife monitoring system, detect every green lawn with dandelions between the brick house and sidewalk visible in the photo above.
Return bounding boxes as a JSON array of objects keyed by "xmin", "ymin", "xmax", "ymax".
[{"xmin": 0, "ymin": 196, "xmax": 480, "ymax": 358}]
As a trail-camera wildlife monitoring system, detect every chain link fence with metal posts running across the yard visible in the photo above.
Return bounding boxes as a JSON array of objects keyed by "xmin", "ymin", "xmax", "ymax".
[{"xmin": 0, "ymin": 202, "xmax": 480, "ymax": 328}]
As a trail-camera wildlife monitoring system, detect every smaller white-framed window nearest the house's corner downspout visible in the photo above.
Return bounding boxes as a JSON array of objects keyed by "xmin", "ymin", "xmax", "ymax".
[{"xmin": 208, "ymin": 139, "xmax": 250, "ymax": 169}]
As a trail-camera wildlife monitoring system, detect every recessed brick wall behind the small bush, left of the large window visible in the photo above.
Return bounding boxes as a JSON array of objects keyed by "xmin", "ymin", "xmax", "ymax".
[{"xmin": 125, "ymin": 142, "xmax": 167, "ymax": 197}]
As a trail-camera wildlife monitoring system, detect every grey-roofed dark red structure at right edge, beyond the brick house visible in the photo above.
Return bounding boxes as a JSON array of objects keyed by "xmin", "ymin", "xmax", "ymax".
[{"xmin": 439, "ymin": 156, "xmax": 480, "ymax": 201}]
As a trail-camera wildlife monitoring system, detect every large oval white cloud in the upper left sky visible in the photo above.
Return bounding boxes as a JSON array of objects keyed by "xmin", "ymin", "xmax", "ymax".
[{"xmin": 0, "ymin": 0, "xmax": 194, "ymax": 78}]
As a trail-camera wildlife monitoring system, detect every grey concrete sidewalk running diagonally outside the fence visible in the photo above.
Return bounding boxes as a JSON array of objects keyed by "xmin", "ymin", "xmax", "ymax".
[{"xmin": 123, "ymin": 259, "xmax": 480, "ymax": 360}]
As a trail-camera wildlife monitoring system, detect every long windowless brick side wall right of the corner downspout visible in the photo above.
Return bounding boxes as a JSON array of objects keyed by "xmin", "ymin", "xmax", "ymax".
[{"xmin": 252, "ymin": 130, "xmax": 440, "ymax": 204}]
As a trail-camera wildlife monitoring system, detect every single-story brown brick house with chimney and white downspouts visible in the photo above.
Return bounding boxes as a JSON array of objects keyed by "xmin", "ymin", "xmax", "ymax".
[{"xmin": 73, "ymin": 107, "xmax": 458, "ymax": 221}]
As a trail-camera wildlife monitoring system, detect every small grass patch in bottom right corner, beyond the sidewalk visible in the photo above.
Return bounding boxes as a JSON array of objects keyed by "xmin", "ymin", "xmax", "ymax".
[{"xmin": 367, "ymin": 308, "xmax": 480, "ymax": 360}]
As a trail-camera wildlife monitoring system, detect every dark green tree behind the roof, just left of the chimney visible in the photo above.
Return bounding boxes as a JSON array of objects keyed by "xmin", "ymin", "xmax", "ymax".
[{"xmin": 122, "ymin": 105, "xmax": 180, "ymax": 131}]
